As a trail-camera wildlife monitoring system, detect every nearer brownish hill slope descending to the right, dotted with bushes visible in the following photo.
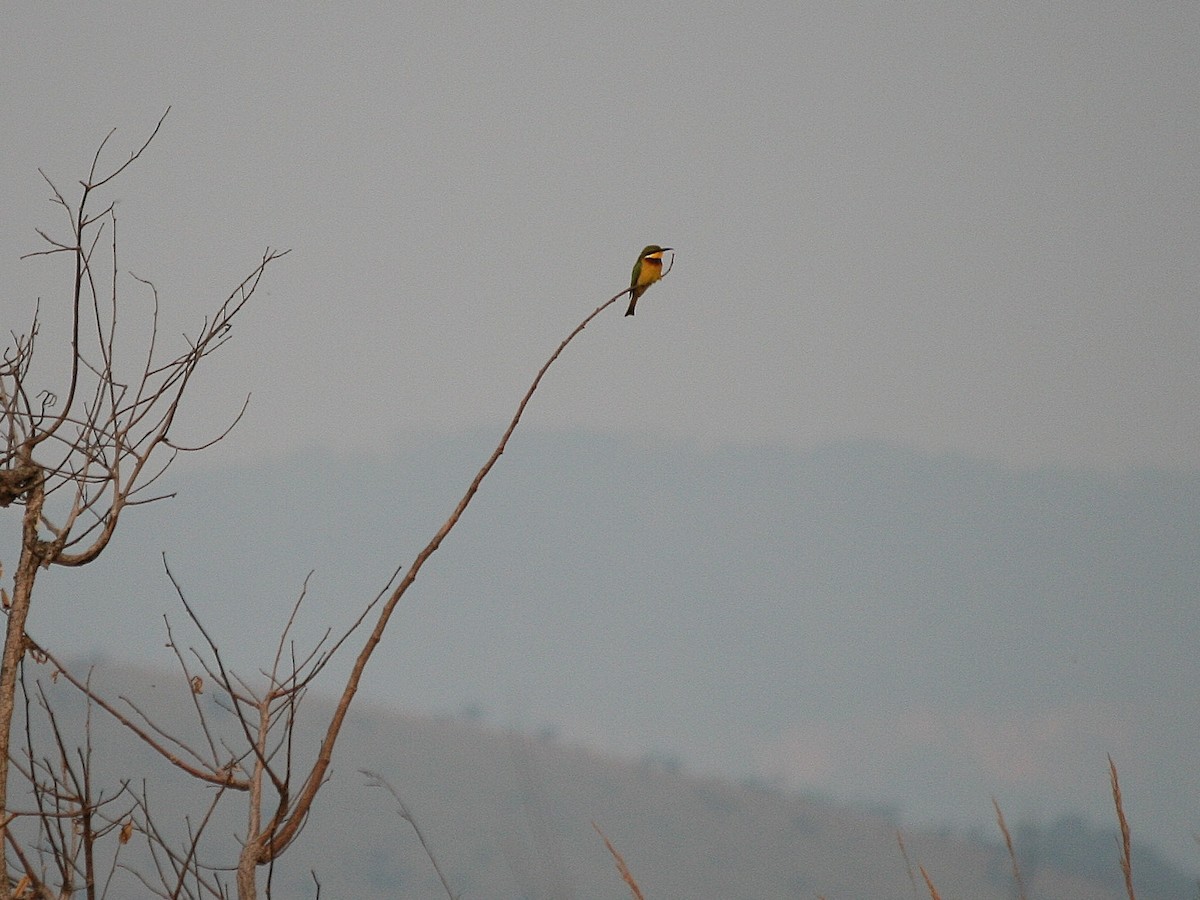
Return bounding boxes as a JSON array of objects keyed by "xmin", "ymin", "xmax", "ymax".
[{"xmin": 16, "ymin": 664, "xmax": 1194, "ymax": 900}]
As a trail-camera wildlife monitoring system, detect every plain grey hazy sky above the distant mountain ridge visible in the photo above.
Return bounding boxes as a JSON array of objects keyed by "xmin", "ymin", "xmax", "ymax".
[{"xmin": 0, "ymin": 2, "xmax": 1200, "ymax": 468}]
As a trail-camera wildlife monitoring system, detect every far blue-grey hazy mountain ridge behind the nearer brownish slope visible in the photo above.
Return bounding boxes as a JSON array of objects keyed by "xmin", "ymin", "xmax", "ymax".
[{"xmin": 5, "ymin": 433, "xmax": 1200, "ymax": 869}]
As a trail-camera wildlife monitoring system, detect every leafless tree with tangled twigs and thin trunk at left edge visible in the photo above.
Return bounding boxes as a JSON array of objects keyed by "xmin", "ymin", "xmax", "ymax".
[{"xmin": 0, "ymin": 110, "xmax": 286, "ymax": 900}]
